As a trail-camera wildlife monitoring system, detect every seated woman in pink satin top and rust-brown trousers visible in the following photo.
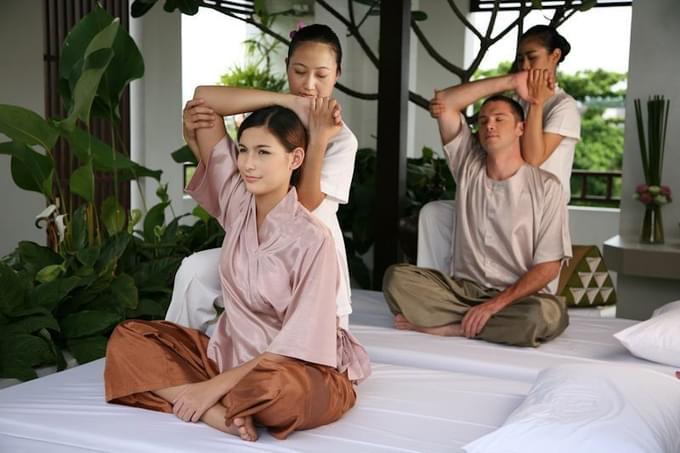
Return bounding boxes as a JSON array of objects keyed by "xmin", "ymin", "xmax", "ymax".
[{"xmin": 105, "ymin": 100, "xmax": 370, "ymax": 441}]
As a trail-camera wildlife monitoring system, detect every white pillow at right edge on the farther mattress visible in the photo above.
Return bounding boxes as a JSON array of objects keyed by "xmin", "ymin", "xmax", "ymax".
[{"xmin": 614, "ymin": 301, "xmax": 680, "ymax": 367}]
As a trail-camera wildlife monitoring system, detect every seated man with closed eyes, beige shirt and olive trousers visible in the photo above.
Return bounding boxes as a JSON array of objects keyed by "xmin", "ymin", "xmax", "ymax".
[{"xmin": 383, "ymin": 82, "xmax": 571, "ymax": 346}]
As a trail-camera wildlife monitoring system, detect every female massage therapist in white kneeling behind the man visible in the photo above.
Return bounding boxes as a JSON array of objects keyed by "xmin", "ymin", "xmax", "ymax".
[{"xmin": 418, "ymin": 25, "xmax": 581, "ymax": 274}]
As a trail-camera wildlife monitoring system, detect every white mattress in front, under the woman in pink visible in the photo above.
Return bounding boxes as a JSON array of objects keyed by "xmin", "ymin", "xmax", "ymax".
[{"xmin": 0, "ymin": 359, "xmax": 530, "ymax": 453}]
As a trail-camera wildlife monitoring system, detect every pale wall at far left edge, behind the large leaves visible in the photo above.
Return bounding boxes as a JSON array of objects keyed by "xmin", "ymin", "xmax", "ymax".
[{"xmin": 0, "ymin": 0, "xmax": 46, "ymax": 256}]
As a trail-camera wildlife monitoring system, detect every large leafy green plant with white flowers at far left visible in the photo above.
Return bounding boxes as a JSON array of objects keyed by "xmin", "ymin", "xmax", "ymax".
[{"xmin": 0, "ymin": 7, "xmax": 223, "ymax": 380}]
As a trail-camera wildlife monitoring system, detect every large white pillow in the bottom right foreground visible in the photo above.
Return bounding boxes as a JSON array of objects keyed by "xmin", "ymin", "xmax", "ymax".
[{"xmin": 463, "ymin": 363, "xmax": 680, "ymax": 453}]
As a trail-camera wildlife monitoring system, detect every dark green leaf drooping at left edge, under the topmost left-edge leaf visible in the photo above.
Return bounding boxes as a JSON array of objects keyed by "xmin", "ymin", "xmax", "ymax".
[{"xmin": 0, "ymin": 142, "xmax": 54, "ymax": 199}]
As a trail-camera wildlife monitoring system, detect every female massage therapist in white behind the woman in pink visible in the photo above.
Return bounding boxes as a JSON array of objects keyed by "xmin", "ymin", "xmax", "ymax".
[{"xmin": 165, "ymin": 24, "xmax": 357, "ymax": 331}]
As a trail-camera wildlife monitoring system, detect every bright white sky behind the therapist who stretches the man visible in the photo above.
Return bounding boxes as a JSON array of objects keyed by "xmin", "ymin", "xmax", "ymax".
[{"xmin": 467, "ymin": 6, "xmax": 632, "ymax": 73}]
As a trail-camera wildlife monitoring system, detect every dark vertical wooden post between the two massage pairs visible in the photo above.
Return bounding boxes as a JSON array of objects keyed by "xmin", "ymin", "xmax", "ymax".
[{"xmin": 373, "ymin": 0, "xmax": 411, "ymax": 289}]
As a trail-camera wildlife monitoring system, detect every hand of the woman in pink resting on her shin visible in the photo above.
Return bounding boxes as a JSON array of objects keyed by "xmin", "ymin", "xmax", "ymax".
[{"xmin": 172, "ymin": 373, "xmax": 233, "ymax": 422}]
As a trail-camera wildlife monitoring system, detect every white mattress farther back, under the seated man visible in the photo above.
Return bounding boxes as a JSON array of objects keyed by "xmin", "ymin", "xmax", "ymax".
[{"xmin": 350, "ymin": 290, "xmax": 675, "ymax": 382}]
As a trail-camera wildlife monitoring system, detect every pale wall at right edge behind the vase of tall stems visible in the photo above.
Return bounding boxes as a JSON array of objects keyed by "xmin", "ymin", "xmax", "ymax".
[{"xmin": 619, "ymin": 0, "xmax": 680, "ymax": 242}]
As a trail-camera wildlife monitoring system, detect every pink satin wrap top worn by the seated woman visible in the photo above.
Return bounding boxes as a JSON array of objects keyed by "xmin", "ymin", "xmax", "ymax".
[{"xmin": 187, "ymin": 137, "xmax": 370, "ymax": 381}]
